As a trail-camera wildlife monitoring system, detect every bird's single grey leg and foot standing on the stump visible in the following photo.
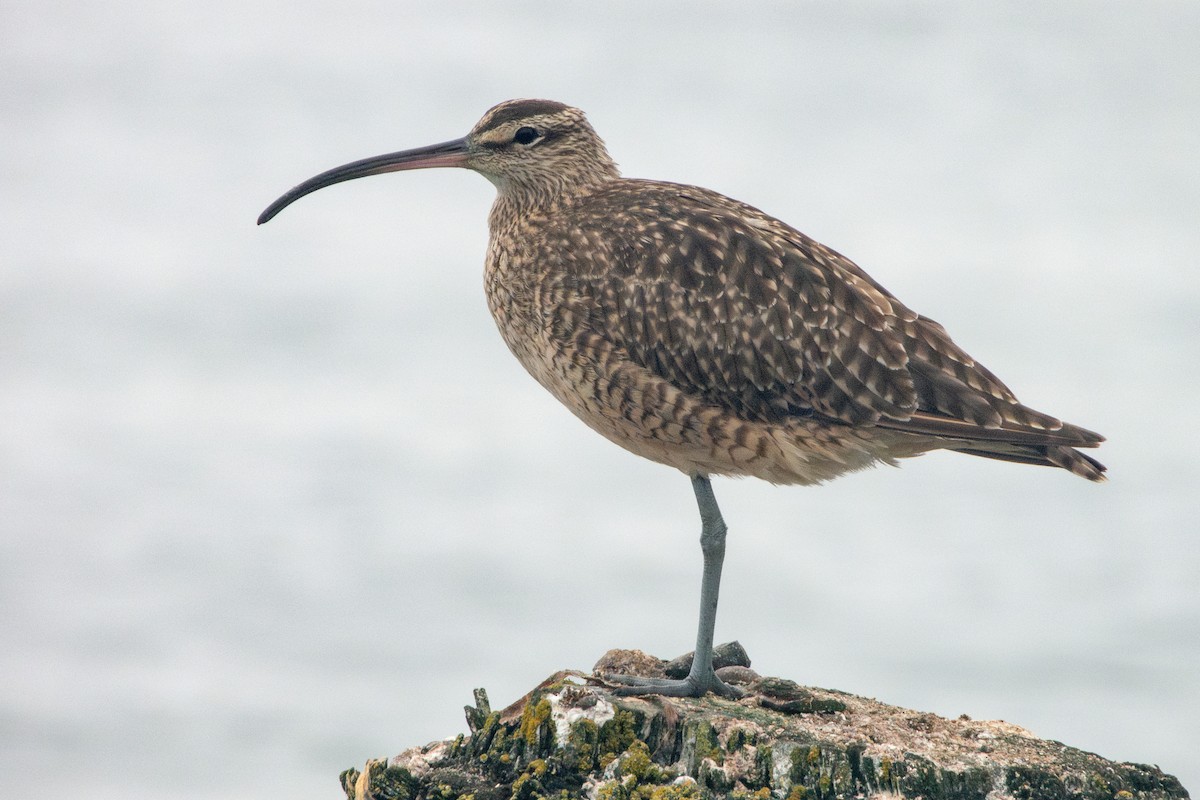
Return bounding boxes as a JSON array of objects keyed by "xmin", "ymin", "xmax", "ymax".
[{"xmin": 608, "ymin": 475, "xmax": 742, "ymax": 697}]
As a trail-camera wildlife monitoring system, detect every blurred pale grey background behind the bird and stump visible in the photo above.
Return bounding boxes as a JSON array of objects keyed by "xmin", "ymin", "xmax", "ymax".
[{"xmin": 0, "ymin": 0, "xmax": 1200, "ymax": 799}]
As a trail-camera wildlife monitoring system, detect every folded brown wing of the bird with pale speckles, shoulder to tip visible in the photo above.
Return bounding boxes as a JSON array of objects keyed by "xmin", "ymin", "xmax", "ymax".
[{"xmin": 556, "ymin": 181, "xmax": 1094, "ymax": 441}]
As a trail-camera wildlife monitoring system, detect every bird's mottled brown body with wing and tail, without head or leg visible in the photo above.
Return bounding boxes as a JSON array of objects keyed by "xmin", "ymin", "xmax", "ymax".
[{"xmin": 488, "ymin": 179, "xmax": 1103, "ymax": 483}]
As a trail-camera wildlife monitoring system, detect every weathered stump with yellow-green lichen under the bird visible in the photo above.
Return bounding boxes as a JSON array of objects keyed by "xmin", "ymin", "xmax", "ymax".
[{"xmin": 342, "ymin": 645, "xmax": 1188, "ymax": 800}]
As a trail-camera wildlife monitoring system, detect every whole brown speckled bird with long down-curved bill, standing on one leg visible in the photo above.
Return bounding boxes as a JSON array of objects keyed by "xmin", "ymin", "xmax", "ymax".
[{"xmin": 258, "ymin": 100, "xmax": 1105, "ymax": 697}]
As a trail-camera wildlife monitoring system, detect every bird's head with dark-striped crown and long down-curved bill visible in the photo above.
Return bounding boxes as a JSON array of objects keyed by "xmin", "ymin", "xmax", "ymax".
[{"xmin": 258, "ymin": 100, "xmax": 618, "ymax": 224}]
